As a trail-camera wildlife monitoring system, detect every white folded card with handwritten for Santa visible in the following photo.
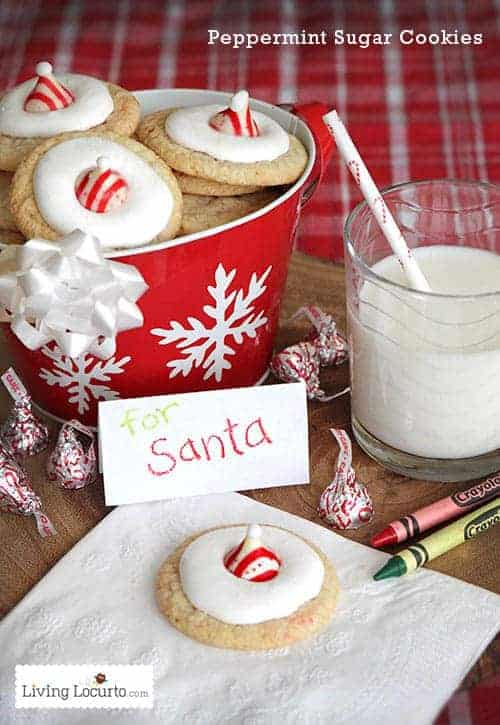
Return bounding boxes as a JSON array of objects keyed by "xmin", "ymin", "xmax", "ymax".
[{"xmin": 99, "ymin": 383, "xmax": 309, "ymax": 506}]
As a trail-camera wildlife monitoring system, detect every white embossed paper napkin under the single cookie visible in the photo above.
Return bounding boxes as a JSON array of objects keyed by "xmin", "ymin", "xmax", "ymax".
[{"xmin": 0, "ymin": 493, "xmax": 500, "ymax": 725}]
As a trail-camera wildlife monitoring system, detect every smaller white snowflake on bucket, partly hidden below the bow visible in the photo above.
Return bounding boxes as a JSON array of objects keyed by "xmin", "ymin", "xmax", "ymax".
[{"xmin": 39, "ymin": 346, "xmax": 132, "ymax": 415}]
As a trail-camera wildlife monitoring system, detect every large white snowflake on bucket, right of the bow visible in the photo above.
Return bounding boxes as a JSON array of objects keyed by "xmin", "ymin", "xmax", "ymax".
[{"xmin": 151, "ymin": 264, "xmax": 272, "ymax": 382}]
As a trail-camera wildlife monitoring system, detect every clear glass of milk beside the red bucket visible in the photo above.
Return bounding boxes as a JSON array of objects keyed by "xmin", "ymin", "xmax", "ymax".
[{"xmin": 344, "ymin": 180, "xmax": 500, "ymax": 481}]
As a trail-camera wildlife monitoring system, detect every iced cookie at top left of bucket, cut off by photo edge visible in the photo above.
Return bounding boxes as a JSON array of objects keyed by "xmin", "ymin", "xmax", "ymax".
[{"xmin": 0, "ymin": 61, "xmax": 140, "ymax": 171}]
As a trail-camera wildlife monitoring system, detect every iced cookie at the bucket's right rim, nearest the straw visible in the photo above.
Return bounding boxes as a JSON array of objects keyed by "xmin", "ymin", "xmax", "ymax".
[{"xmin": 137, "ymin": 91, "xmax": 307, "ymax": 186}]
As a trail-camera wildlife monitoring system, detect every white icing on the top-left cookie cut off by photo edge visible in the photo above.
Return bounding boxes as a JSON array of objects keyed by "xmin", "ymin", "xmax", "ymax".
[{"xmin": 0, "ymin": 73, "xmax": 114, "ymax": 138}]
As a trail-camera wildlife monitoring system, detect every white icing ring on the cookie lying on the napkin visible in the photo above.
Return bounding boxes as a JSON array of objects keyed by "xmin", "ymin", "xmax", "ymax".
[{"xmin": 179, "ymin": 526, "xmax": 325, "ymax": 624}]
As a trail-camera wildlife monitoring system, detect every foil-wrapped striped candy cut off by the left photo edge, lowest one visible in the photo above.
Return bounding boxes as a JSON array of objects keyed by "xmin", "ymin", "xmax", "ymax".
[{"xmin": 0, "ymin": 442, "xmax": 55, "ymax": 537}]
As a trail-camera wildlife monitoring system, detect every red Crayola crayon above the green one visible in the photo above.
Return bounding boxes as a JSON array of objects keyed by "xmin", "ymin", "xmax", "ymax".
[{"xmin": 371, "ymin": 473, "xmax": 500, "ymax": 548}]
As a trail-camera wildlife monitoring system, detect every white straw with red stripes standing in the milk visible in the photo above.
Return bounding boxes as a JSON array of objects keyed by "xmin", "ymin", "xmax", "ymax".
[{"xmin": 323, "ymin": 111, "xmax": 432, "ymax": 292}]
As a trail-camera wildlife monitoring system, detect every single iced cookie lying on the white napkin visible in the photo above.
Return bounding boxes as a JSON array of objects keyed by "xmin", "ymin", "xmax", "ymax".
[{"xmin": 156, "ymin": 524, "xmax": 339, "ymax": 650}]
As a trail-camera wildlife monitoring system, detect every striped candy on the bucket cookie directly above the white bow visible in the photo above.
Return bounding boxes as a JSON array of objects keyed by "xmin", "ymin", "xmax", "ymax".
[{"xmin": 75, "ymin": 156, "xmax": 128, "ymax": 214}]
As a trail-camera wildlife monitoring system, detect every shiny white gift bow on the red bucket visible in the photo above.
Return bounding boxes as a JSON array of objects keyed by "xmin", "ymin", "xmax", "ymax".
[{"xmin": 0, "ymin": 229, "xmax": 148, "ymax": 360}]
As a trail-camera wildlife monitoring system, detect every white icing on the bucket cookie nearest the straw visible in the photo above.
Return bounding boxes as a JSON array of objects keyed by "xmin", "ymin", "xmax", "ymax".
[{"xmin": 165, "ymin": 105, "xmax": 290, "ymax": 164}]
